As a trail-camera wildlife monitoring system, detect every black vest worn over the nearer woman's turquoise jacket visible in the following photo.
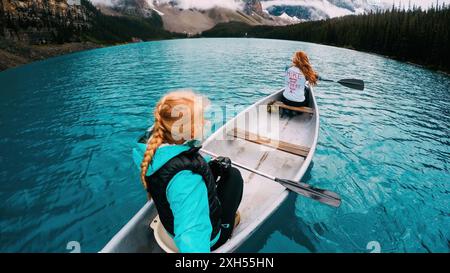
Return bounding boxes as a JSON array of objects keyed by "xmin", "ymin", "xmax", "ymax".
[{"xmin": 145, "ymin": 147, "xmax": 222, "ymax": 239}]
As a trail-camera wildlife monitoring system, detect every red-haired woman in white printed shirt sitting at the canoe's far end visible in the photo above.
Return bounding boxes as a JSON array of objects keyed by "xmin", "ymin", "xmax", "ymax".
[{"xmin": 281, "ymin": 51, "xmax": 318, "ymax": 107}]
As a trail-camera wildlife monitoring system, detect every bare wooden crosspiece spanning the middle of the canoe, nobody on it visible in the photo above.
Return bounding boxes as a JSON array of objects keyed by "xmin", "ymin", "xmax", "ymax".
[{"xmin": 228, "ymin": 128, "xmax": 310, "ymax": 157}]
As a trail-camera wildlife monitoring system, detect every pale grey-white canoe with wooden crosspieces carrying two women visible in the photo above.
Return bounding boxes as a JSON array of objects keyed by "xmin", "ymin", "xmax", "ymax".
[{"xmin": 100, "ymin": 89, "xmax": 319, "ymax": 253}]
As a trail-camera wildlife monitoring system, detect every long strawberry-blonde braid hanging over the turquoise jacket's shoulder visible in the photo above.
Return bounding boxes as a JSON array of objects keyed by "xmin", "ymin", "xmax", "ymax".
[{"xmin": 141, "ymin": 104, "xmax": 164, "ymax": 189}]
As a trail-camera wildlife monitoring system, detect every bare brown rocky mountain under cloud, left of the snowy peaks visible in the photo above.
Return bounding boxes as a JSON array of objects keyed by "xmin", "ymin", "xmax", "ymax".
[{"xmin": 94, "ymin": 0, "xmax": 291, "ymax": 35}]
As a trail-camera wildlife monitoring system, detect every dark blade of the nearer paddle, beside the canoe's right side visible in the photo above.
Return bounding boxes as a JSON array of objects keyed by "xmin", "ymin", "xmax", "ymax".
[{"xmin": 276, "ymin": 179, "xmax": 341, "ymax": 208}]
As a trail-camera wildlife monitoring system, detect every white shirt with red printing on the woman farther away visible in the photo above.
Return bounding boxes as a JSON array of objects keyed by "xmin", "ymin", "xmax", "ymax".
[{"xmin": 283, "ymin": 66, "xmax": 308, "ymax": 102}]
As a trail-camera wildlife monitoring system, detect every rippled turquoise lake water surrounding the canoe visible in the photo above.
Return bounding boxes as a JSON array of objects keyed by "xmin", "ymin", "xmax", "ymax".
[{"xmin": 0, "ymin": 39, "xmax": 450, "ymax": 252}]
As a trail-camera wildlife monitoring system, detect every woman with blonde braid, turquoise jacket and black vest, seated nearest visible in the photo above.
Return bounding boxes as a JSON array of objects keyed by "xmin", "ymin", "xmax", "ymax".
[{"xmin": 133, "ymin": 91, "xmax": 243, "ymax": 252}]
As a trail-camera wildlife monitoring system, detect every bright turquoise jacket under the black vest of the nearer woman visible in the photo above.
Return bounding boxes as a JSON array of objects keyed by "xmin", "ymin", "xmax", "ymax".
[{"xmin": 133, "ymin": 142, "xmax": 220, "ymax": 252}]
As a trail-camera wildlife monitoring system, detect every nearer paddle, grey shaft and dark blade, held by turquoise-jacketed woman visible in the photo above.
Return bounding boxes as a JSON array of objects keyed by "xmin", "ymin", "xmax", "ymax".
[{"xmin": 201, "ymin": 149, "xmax": 341, "ymax": 207}]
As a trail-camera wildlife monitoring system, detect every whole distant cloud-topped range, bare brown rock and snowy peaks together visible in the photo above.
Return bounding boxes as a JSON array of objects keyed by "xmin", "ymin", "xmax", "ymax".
[{"xmin": 91, "ymin": 0, "xmax": 390, "ymax": 35}]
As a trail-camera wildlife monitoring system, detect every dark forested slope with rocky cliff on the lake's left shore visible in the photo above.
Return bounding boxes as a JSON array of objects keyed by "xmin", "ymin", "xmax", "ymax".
[{"xmin": 0, "ymin": 0, "xmax": 178, "ymax": 71}]
